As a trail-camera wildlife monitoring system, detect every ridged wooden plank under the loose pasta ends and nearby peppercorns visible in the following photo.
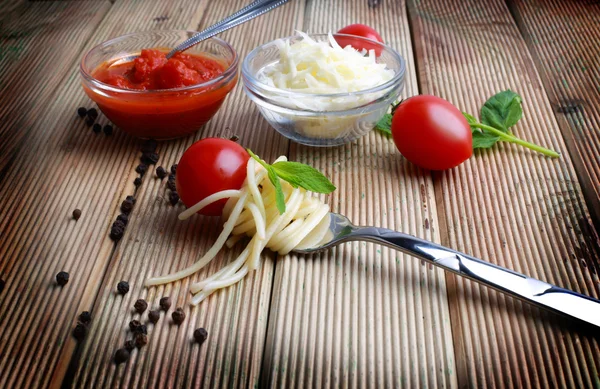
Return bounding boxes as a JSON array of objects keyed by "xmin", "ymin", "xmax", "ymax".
[{"xmin": 65, "ymin": 0, "xmax": 304, "ymax": 388}]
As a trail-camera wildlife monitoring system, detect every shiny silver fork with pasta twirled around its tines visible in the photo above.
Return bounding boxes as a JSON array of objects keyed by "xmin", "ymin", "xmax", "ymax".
[{"xmin": 294, "ymin": 212, "xmax": 600, "ymax": 327}]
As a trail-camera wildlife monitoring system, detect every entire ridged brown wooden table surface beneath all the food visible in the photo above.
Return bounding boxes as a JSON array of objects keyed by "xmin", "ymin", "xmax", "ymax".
[{"xmin": 0, "ymin": 0, "xmax": 600, "ymax": 388}]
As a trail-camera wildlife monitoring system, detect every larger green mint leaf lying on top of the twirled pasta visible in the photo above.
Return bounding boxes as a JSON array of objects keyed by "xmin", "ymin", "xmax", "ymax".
[{"xmin": 272, "ymin": 161, "xmax": 335, "ymax": 193}]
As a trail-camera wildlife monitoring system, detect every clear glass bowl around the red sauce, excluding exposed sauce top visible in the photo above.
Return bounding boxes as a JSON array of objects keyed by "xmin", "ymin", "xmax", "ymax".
[{"xmin": 79, "ymin": 31, "xmax": 238, "ymax": 139}]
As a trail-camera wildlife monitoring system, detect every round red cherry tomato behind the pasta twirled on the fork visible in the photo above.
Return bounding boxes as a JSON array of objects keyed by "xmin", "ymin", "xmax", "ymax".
[{"xmin": 175, "ymin": 138, "xmax": 250, "ymax": 216}]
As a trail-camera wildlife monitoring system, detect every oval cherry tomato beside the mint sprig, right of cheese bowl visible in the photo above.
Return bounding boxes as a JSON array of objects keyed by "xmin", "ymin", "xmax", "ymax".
[{"xmin": 392, "ymin": 95, "xmax": 473, "ymax": 170}]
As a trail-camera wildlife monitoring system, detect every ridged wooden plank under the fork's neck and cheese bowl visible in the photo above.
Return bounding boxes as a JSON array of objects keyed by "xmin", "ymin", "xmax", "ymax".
[{"xmin": 263, "ymin": 0, "xmax": 457, "ymax": 388}]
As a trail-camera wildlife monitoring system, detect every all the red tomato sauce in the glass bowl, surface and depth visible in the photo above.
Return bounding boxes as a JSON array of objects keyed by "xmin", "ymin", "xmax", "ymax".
[{"xmin": 84, "ymin": 49, "xmax": 237, "ymax": 139}]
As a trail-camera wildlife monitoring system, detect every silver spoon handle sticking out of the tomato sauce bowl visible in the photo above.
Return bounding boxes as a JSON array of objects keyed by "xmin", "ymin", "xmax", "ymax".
[{"xmin": 167, "ymin": 0, "xmax": 289, "ymax": 58}]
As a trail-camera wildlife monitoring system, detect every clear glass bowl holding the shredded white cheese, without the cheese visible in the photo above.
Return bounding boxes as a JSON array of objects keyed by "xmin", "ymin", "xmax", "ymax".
[{"xmin": 242, "ymin": 34, "xmax": 406, "ymax": 146}]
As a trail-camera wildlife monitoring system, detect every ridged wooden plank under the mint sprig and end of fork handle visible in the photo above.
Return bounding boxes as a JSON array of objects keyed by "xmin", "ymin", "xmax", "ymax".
[{"xmin": 409, "ymin": 0, "xmax": 600, "ymax": 388}]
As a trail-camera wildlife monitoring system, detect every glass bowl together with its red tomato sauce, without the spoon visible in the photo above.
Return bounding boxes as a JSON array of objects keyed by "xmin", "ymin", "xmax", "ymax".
[{"xmin": 80, "ymin": 31, "xmax": 238, "ymax": 140}]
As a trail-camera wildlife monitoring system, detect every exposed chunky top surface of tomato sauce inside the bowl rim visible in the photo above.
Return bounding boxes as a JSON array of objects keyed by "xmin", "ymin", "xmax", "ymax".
[{"xmin": 92, "ymin": 49, "xmax": 225, "ymax": 90}]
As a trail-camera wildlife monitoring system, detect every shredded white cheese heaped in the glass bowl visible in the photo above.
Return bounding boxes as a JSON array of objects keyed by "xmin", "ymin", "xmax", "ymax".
[{"xmin": 257, "ymin": 32, "xmax": 394, "ymax": 111}]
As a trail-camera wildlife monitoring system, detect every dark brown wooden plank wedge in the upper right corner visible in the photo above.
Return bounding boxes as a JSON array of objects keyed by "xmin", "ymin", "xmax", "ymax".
[{"xmin": 508, "ymin": 1, "xmax": 600, "ymax": 228}]
